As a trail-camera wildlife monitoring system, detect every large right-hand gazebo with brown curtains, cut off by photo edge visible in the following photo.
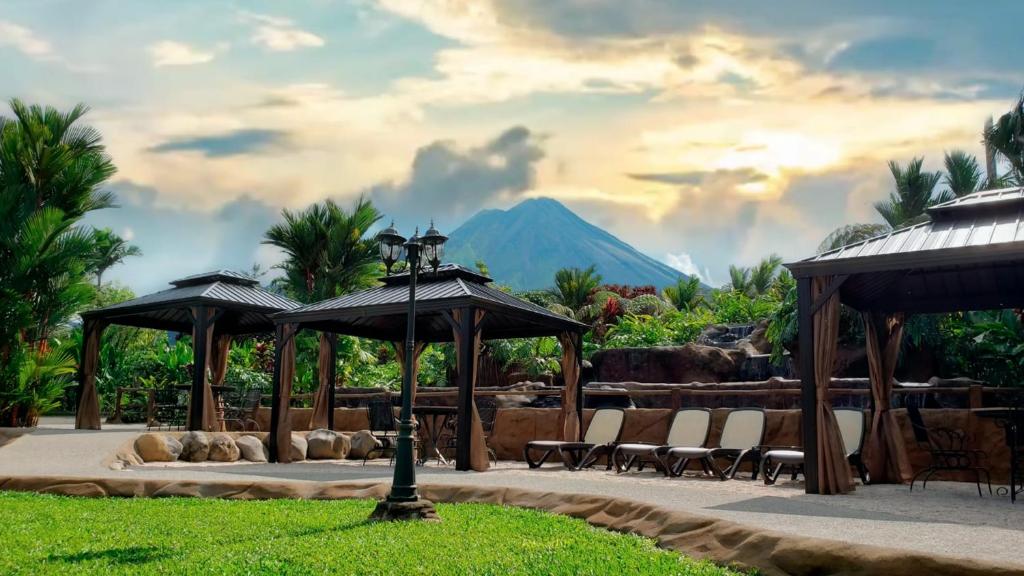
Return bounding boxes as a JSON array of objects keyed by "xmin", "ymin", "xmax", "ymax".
[{"xmin": 786, "ymin": 189, "xmax": 1024, "ymax": 494}]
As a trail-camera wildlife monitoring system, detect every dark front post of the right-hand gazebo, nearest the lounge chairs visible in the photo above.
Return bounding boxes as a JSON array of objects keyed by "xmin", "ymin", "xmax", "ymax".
[{"xmin": 797, "ymin": 277, "xmax": 818, "ymax": 494}]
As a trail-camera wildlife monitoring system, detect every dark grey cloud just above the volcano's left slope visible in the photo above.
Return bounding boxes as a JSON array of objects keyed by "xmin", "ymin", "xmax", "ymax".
[{"xmin": 370, "ymin": 126, "xmax": 544, "ymax": 228}]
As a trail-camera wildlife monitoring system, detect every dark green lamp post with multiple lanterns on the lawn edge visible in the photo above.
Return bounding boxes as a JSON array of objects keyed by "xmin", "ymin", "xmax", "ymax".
[{"xmin": 370, "ymin": 218, "xmax": 447, "ymax": 521}]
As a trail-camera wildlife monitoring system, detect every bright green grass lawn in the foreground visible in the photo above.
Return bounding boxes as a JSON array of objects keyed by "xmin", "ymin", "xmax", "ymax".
[{"xmin": 0, "ymin": 492, "xmax": 737, "ymax": 576}]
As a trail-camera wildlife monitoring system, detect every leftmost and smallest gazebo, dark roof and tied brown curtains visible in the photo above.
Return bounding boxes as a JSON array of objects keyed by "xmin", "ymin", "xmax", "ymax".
[{"xmin": 75, "ymin": 270, "xmax": 299, "ymax": 430}]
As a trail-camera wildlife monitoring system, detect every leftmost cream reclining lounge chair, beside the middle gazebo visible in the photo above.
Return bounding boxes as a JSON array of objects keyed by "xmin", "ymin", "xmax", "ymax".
[{"xmin": 522, "ymin": 408, "xmax": 626, "ymax": 470}]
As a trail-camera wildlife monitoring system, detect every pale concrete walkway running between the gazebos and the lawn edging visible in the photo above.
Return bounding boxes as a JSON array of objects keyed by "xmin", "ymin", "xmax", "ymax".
[{"xmin": 0, "ymin": 418, "xmax": 1024, "ymax": 573}]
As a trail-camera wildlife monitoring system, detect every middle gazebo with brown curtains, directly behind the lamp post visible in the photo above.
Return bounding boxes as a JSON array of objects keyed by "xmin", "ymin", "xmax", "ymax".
[{"xmin": 270, "ymin": 264, "xmax": 587, "ymax": 470}]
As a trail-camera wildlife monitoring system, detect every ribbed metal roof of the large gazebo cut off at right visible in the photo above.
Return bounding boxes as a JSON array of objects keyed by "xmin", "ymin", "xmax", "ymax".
[{"xmin": 786, "ymin": 188, "xmax": 1024, "ymax": 313}]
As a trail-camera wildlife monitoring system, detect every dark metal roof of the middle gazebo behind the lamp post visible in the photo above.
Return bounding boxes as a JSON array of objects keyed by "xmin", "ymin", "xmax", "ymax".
[{"xmin": 273, "ymin": 264, "xmax": 586, "ymax": 342}]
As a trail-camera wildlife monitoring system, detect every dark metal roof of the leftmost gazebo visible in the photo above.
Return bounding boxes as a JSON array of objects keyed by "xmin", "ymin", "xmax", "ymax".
[{"xmin": 82, "ymin": 270, "xmax": 299, "ymax": 334}]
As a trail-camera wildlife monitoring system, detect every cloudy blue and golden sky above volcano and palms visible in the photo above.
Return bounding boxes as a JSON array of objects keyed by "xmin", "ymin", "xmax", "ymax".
[{"xmin": 0, "ymin": 0, "xmax": 1024, "ymax": 293}]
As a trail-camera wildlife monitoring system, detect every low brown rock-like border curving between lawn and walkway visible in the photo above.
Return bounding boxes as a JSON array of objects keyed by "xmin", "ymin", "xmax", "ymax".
[{"xmin": 0, "ymin": 477, "xmax": 1024, "ymax": 576}]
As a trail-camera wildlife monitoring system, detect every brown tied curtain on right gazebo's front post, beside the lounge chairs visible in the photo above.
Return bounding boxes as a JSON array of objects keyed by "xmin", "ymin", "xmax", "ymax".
[{"xmin": 811, "ymin": 277, "xmax": 853, "ymax": 494}]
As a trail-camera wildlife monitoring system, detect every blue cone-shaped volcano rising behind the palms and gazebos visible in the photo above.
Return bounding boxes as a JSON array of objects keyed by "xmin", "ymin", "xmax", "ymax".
[{"xmin": 445, "ymin": 198, "xmax": 686, "ymax": 290}]
